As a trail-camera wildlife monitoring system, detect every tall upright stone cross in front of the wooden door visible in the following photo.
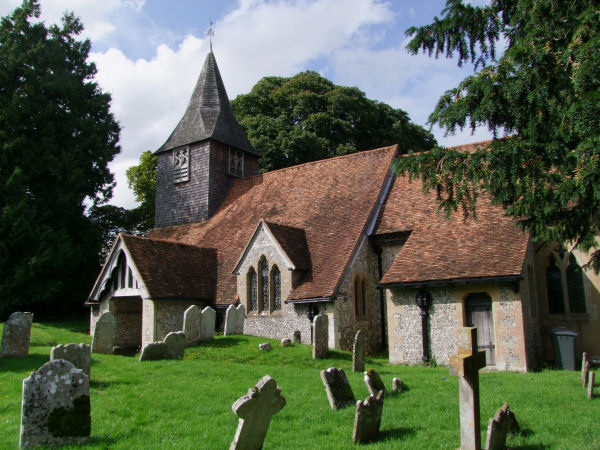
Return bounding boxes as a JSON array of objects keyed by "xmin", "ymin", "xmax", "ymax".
[{"xmin": 450, "ymin": 327, "xmax": 485, "ymax": 450}]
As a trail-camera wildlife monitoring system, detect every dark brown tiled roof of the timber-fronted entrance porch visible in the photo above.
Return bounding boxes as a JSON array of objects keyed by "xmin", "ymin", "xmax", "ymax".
[{"xmin": 121, "ymin": 234, "xmax": 217, "ymax": 300}]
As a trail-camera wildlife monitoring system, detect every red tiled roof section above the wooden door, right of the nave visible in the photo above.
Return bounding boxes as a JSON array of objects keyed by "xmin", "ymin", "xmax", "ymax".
[{"xmin": 374, "ymin": 148, "xmax": 528, "ymax": 285}]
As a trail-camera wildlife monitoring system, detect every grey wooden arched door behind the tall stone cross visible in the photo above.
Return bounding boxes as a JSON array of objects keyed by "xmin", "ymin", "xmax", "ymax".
[{"xmin": 466, "ymin": 293, "xmax": 496, "ymax": 366}]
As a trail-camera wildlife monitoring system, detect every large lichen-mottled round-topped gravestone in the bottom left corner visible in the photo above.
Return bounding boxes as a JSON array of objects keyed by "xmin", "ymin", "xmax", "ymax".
[{"xmin": 19, "ymin": 359, "xmax": 92, "ymax": 448}]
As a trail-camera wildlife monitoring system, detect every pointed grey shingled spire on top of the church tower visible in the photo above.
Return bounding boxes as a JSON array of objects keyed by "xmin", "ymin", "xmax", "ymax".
[{"xmin": 156, "ymin": 51, "xmax": 258, "ymax": 155}]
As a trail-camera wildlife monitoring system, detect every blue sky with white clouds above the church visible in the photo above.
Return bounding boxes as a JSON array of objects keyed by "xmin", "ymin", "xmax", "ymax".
[{"xmin": 0, "ymin": 0, "xmax": 491, "ymax": 208}]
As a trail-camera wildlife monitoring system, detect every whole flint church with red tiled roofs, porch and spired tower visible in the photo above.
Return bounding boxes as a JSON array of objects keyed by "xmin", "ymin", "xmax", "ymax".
[{"xmin": 87, "ymin": 52, "xmax": 600, "ymax": 371}]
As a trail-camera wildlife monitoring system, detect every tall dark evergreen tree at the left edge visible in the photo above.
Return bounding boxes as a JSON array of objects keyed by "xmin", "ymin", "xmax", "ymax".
[{"xmin": 0, "ymin": 0, "xmax": 120, "ymax": 316}]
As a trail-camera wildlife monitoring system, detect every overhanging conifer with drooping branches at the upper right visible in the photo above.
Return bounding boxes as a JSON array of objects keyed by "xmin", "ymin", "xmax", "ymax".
[{"xmin": 397, "ymin": 0, "xmax": 600, "ymax": 270}]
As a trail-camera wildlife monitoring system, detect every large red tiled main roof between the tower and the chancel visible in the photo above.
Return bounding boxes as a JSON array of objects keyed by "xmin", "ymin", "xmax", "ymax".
[{"xmin": 150, "ymin": 146, "xmax": 397, "ymax": 304}]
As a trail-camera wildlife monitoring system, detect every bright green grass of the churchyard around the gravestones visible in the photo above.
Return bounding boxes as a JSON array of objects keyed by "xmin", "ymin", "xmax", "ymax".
[{"xmin": 0, "ymin": 322, "xmax": 600, "ymax": 449}]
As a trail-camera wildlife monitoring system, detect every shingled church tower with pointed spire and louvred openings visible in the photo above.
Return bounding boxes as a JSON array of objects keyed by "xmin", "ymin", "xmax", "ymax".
[{"xmin": 154, "ymin": 50, "xmax": 259, "ymax": 228}]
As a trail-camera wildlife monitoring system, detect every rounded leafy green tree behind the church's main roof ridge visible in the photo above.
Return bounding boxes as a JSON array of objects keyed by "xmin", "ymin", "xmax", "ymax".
[{"xmin": 231, "ymin": 72, "xmax": 435, "ymax": 172}]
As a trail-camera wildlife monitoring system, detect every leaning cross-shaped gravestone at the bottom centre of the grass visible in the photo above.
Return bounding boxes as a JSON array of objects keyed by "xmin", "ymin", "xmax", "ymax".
[{"xmin": 229, "ymin": 375, "xmax": 285, "ymax": 450}]
